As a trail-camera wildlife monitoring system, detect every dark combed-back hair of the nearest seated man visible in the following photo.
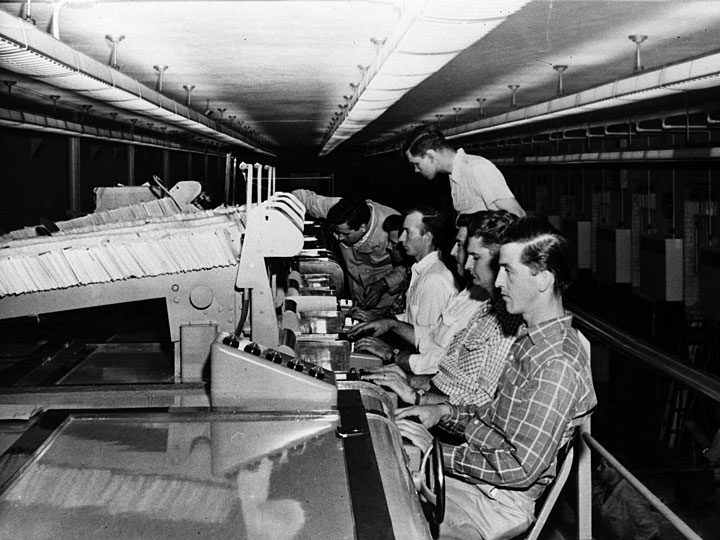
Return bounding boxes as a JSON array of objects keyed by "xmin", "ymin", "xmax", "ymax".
[{"xmin": 504, "ymin": 217, "xmax": 577, "ymax": 294}]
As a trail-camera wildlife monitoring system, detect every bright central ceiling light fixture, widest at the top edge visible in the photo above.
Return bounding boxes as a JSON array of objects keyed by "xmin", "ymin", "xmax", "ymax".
[{"xmin": 320, "ymin": 0, "xmax": 529, "ymax": 156}]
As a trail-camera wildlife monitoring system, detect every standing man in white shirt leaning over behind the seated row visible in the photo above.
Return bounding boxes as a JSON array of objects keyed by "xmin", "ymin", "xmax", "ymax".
[{"xmin": 402, "ymin": 126, "xmax": 525, "ymax": 217}]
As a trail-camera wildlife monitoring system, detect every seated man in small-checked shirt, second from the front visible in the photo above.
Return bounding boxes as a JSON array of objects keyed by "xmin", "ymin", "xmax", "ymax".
[{"xmin": 365, "ymin": 211, "xmax": 522, "ymax": 406}]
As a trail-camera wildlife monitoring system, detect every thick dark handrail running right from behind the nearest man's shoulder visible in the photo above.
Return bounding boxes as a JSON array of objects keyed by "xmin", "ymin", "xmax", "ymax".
[{"xmin": 568, "ymin": 305, "xmax": 720, "ymax": 403}]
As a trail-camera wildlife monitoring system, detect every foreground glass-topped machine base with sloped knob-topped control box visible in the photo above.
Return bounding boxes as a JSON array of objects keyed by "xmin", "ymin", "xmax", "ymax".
[{"xmin": 0, "ymin": 316, "xmax": 443, "ymax": 540}]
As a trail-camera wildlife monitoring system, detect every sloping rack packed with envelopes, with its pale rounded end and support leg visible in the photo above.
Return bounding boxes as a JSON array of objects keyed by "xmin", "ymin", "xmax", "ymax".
[{"xmin": 0, "ymin": 178, "xmax": 304, "ymax": 381}]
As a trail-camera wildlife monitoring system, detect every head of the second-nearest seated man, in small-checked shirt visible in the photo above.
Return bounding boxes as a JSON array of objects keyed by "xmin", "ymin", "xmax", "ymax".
[{"xmin": 465, "ymin": 210, "xmax": 518, "ymax": 294}]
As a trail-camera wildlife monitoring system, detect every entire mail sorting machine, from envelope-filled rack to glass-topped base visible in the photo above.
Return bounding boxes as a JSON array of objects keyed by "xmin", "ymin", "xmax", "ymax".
[{"xmin": 0, "ymin": 179, "xmax": 442, "ymax": 539}]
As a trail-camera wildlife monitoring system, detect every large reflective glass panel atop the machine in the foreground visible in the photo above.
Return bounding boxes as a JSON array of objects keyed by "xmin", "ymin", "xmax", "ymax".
[{"xmin": 0, "ymin": 414, "xmax": 354, "ymax": 540}]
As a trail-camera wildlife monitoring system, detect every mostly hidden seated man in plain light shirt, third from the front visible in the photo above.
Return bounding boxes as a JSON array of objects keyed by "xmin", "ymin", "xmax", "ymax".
[{"xmin": 348, "ymin": 212, "xmax": 487, "ymax": 374}]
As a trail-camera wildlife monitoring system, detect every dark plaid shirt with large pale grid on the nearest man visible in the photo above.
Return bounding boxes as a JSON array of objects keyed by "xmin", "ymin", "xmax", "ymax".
[{"xmin": 443, "ymin": 315, "xmax": 597, "ymax": 499}]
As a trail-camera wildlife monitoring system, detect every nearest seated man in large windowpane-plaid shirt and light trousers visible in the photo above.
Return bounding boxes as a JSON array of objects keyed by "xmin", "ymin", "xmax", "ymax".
[{"xmin": 396, "ymin": 218, "xmax": 596, "ymax": 540}]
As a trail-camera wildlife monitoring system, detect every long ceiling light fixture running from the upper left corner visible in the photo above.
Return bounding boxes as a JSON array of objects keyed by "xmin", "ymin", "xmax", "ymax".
[{"xmin": 0, "ymin": 11, "xmax": 275, "ymax": 156}]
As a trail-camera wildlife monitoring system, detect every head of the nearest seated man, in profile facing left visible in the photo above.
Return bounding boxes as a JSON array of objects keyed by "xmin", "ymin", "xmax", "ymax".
[{"xmin": 495, "ymin": 217, "xmax": 576, "ymax": 320}]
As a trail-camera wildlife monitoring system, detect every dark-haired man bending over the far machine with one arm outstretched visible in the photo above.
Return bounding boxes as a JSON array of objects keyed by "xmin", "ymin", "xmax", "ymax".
[{"xmin": 292, "ymin": 189, "xmax": 405, "ymax": 309}]
